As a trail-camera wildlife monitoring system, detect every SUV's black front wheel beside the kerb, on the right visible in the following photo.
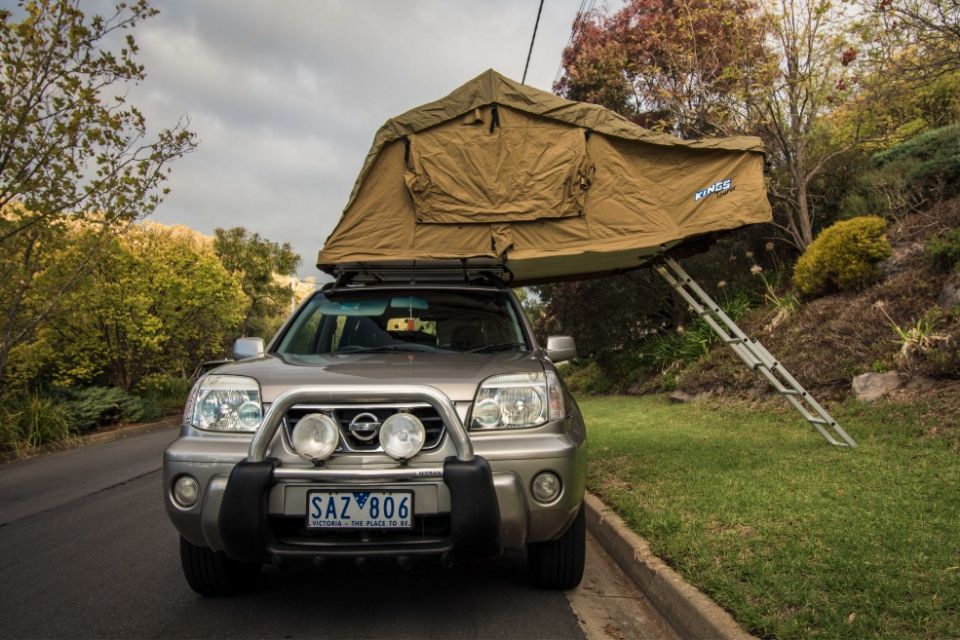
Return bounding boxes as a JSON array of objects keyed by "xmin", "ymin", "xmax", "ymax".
[{"xmin": 527, "ymin": 507, "xmax": 587, "ymax": 589}]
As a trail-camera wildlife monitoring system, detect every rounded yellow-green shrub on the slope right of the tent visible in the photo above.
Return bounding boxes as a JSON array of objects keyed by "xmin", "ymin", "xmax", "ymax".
[{"xmin": 793, "ymin": 216, "xmax": 892, "ymax": 296}]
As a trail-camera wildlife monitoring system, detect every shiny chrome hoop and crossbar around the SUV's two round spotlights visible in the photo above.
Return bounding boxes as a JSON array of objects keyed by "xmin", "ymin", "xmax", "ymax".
[{"xmin": 247, "ymin": 385, "xmax": 474, "ymax": 468}]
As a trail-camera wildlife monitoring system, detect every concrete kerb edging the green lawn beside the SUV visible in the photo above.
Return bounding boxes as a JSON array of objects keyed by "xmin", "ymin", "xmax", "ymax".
[{"xmin": 585, "ymin": 493, "xmax": 754, "ymax": 640}]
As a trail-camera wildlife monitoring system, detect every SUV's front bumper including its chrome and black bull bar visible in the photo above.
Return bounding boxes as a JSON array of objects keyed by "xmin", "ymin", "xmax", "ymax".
[{"xmin": 164, "ymin": 386, "xmax": 586, "ymax": 562}]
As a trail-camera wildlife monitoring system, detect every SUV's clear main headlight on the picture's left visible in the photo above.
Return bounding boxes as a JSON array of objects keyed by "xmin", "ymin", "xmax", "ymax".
[{"xmin": 187, "ymin": 376, "xmax": 263, "ymax": 432}]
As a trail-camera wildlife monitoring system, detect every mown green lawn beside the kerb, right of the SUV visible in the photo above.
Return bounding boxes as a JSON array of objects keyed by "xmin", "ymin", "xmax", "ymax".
[{"xmin": 581, "ymin": 396, "xmax": 960, "ymax": 638}]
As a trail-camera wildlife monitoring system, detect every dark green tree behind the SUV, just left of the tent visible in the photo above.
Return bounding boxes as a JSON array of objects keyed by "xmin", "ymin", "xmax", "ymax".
[{"xmin": 214, "ymin": 227, "xmax": 300, "ymax": 337}]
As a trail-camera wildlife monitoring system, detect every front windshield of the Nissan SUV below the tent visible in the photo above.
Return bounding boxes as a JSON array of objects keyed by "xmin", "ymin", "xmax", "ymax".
[{"xmin": 276, "ymin": 289, "xmax": 529, "ymax": 355}]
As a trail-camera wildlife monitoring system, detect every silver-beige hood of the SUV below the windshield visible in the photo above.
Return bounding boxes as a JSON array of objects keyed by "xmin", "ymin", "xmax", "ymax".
[{"xmin": 214, "ymin": 352, "xmax": 544, "ymax": 403}]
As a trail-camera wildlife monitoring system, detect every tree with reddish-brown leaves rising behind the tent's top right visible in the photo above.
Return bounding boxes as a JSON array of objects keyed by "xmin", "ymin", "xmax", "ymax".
[{"xmin": 555, "ymin": 0, "xmax": 771, "ymax": 138}]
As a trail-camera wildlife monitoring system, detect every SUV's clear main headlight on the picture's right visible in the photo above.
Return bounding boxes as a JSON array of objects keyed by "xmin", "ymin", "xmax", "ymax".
[{"xmin": 470, "ymin": 371, "xmax": 566, "ymax": 429}]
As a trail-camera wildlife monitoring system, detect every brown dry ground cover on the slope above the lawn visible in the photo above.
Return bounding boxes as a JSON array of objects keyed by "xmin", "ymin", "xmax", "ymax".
[{"xmin": 677, "ymin": 199, "xmax": 960, "ymax": 399}]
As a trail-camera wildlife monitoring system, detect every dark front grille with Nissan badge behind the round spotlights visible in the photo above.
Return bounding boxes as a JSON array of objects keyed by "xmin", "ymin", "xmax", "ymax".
[{"xmin": 283, "ymin": 403, "xmax": 445, "ymax": 453}]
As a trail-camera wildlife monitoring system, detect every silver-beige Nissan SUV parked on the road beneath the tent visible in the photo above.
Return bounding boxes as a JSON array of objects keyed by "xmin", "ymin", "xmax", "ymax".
[{"xmin": 163, "ymin": 271, "xmax": 586, "ymax": 595}]
